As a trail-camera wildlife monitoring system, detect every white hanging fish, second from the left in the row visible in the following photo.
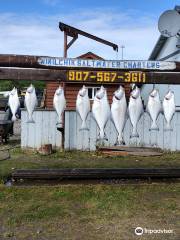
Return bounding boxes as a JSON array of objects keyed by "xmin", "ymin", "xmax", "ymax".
[{"xmin": 24, "ymin": 84, "xmax": 38, "ymax": 123}]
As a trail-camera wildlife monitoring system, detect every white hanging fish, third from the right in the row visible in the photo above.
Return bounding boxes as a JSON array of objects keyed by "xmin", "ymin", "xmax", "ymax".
[{"xmin": 128, "ymin": 86, "xmax": 144, "ymax": 137}]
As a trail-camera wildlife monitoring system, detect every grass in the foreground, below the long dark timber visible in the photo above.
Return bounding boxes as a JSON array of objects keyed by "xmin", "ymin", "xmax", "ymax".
[{"xmin": 0, "ymin": 183, "xmax": 180, "ymax": 240}]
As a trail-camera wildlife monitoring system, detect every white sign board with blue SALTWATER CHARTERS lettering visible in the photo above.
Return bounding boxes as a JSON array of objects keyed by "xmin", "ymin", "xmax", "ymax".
[{"xmin": 38, "ymin": 57, "xmax": 176, "ymax": 70}]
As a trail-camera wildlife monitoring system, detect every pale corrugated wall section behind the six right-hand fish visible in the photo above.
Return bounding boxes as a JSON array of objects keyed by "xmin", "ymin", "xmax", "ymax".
[{"xmin": 64, "ymin": 111, "xmax": 180, "ymax": 151}]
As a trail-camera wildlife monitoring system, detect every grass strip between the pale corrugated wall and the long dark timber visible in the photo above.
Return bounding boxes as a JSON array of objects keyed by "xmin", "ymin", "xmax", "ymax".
[{"xmin": 0, "ymin": 148, "xmax": 180, "ymax": 180}]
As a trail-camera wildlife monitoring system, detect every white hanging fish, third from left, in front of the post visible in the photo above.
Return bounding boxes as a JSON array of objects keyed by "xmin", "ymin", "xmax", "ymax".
[{"xmin": 53, "ymin": 86, "xmax": 66, "ymax": 124}]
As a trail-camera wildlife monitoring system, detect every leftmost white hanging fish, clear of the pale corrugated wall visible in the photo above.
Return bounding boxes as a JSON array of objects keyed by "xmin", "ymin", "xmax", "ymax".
[{"xmin": 8, "ymin": 87, "xmax": 20, "ymax": 122}]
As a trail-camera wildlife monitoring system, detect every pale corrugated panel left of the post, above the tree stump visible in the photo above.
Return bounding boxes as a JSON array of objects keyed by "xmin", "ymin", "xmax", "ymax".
[{"xmin": 21, "ymin": 110, "xmax": 62, "ymax": 149}]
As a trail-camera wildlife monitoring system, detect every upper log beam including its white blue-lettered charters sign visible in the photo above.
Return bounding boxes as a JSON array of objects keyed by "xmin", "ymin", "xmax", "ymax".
[{"xmin": 0, "ymin": 54, "xmax": 180, "ymax": 72}]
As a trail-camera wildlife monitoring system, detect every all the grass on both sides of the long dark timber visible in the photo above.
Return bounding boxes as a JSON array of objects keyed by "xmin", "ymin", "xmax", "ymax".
[{"xmin": 0, "ymin": 148, "xmax": 180, "ymax": 240}]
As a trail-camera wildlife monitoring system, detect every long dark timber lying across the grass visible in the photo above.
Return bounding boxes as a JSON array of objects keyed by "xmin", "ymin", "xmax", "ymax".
[{"xmin": 12, "ymin": 168, "xmax": 180, "ymax": 180}]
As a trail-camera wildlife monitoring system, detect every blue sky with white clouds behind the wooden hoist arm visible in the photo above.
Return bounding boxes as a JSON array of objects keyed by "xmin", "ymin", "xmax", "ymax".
[{"xmin": 0, "ymin": 0, "xmax": 180, "ymax": 60}]
